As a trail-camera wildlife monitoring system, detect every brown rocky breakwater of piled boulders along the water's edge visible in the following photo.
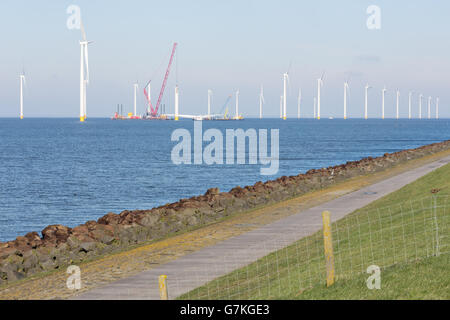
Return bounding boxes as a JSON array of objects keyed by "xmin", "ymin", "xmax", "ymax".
[{"xmin": 0, "ymin": 140, "xmax": 450, "ymax": 285}]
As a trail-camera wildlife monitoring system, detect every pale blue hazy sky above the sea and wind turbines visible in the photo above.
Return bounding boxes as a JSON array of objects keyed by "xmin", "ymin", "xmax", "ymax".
[{"xmin": 0, "ymin": 0, "xmax": 450, "ymax": 118}]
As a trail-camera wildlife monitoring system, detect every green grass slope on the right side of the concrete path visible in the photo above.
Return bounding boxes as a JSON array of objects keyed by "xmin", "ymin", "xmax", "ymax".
[{"xmin": 180, "ymin": 165, "xmax": 450, "ymax": 299}]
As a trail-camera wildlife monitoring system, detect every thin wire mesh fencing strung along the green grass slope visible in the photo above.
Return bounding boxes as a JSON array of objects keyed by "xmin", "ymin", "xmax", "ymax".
[{"xmin": 178, "ymin": 195, "xmax": 450, "ymax": 300}]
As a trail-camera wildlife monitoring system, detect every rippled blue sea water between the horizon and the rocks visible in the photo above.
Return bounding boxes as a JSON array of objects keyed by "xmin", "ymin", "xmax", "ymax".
[{"xmin": 0, "ymin": 118, "xmax": 450, "ymax": 241}]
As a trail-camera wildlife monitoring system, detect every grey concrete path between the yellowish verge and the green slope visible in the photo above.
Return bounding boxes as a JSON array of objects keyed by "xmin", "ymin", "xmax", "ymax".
[{"xmin": 73, "ymin": 156, "xmax": 450, "ymax": 300}]
